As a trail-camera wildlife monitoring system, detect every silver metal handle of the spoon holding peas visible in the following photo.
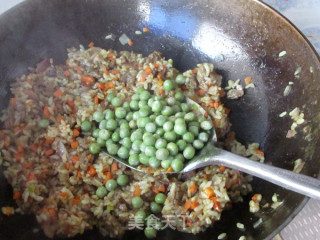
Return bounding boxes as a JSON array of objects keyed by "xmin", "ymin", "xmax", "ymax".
[{"xmin": 208, "ymin": 149, "xmax": 320, "ymax": 200}]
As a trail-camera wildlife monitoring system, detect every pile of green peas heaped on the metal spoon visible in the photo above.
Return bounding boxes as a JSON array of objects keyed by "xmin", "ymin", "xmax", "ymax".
[{"xmin": 89, "ymin": 80, "xmax": 213, "ymax": 172}]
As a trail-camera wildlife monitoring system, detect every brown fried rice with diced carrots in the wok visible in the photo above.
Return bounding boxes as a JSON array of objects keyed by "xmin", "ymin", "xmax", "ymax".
[{"xmin": 0, "ymin": 47, "xmax": 264, "ymax": 238}]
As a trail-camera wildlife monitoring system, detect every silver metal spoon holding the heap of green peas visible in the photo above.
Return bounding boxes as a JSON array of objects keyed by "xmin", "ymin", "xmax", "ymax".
[{"xmin": 104, "ymin": 98, "xmax": 320, "ymax": 200}]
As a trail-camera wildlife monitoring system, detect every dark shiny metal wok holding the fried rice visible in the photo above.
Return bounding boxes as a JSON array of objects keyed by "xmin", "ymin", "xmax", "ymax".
[{"xmin": 0, "ymin": 0, "xmax": 320, "ymax": 240}]
